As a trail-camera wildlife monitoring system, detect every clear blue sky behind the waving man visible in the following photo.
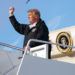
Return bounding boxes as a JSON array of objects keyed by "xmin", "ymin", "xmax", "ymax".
[{"xmin": 0, "ymin": 0, "xmax": 75, "ymax": 47}]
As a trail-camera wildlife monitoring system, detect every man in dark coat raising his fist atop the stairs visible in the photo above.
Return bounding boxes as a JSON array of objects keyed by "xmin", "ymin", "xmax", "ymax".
[{"xmin": 9, "ymin": 7, "xmax": 51, "ymax": 58}]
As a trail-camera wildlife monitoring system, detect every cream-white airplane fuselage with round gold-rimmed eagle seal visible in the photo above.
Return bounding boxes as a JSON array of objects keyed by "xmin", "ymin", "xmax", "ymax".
[{"xmin": 49, "ymin": 26, "xmax": 75, "ymax": 64}]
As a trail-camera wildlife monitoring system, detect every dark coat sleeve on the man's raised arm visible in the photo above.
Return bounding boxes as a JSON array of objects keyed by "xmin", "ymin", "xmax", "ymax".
[{"xmin": 9, "ymin": 16, "xmax": 28, "ymax": 35}]
